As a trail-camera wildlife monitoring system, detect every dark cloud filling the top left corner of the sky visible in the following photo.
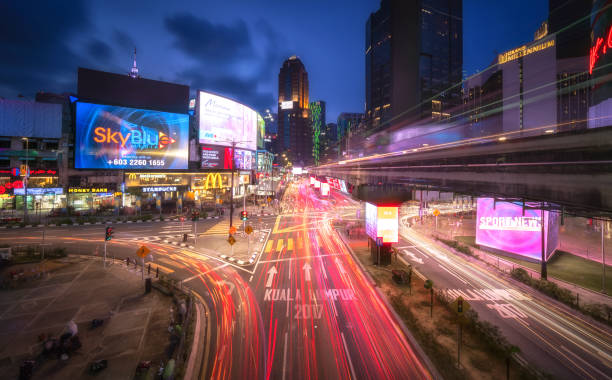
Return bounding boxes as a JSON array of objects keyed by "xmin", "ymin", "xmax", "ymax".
[{"xmin": 0, "ymin": 1, "xmax": 90, "ymax": 97}]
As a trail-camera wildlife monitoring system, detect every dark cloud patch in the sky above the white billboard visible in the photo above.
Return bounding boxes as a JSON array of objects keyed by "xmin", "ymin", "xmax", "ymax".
[{"xmin": 165, "ymin": 13, "xmax": 253, "ymax": 62}]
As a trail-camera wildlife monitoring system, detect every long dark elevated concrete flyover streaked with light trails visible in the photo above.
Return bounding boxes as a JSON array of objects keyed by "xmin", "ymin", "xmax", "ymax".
[{"xmin": 310, "ymin": 127, "xmax": 612, "ymax": 216}]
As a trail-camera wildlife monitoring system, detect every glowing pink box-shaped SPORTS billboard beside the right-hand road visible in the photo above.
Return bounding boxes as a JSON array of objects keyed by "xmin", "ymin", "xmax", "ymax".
[{"xmin": 476, "ymin": 198, "xmax": 559, "ymax": 261}]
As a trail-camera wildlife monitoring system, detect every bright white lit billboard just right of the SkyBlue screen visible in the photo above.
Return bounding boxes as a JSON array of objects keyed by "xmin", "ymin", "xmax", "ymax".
[{"xmin": 198, "ymin": 91, "xmax": 257, "ymax": 150}]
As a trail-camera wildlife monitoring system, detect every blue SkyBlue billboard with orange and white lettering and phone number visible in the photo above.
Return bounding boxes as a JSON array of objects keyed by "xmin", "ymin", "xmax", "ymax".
[{"xmin": 74, "ymin": 102, "xmax": 189, "ymax": 169}]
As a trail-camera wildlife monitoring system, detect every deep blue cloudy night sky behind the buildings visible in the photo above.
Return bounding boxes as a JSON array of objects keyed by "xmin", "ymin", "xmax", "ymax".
[{"xmin": 0, "ymin": 0, "xmax": 548, "ymax": 122}]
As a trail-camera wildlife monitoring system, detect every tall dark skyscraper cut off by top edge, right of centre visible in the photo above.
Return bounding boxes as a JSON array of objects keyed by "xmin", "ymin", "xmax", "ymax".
[{"xmin": 365, "ymin": 0, "xmax": 463, "ymax": 129}]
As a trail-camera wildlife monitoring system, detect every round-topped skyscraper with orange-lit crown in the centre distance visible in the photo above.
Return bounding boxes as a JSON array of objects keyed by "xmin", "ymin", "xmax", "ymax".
[{"xmin": 277, "ymin": 56, "xmax": 313, "ymax": 166}]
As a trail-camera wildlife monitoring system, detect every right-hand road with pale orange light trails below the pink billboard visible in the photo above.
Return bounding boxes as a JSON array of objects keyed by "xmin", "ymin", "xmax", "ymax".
[{"xmin": 398, "ymin": 215, "xmax": 612, "ymax": 379}]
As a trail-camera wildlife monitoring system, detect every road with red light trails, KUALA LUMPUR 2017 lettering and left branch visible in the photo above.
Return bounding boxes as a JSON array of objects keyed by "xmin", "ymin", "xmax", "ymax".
[{"xmin": 0, "ymin": 184, "xmax": 432, "ymax": 379}]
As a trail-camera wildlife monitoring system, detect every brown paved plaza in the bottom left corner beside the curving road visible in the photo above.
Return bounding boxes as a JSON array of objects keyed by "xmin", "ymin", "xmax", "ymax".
[{"xmin": 0, "ymin": 256, "xmax": 173, "ymax": 379}]
